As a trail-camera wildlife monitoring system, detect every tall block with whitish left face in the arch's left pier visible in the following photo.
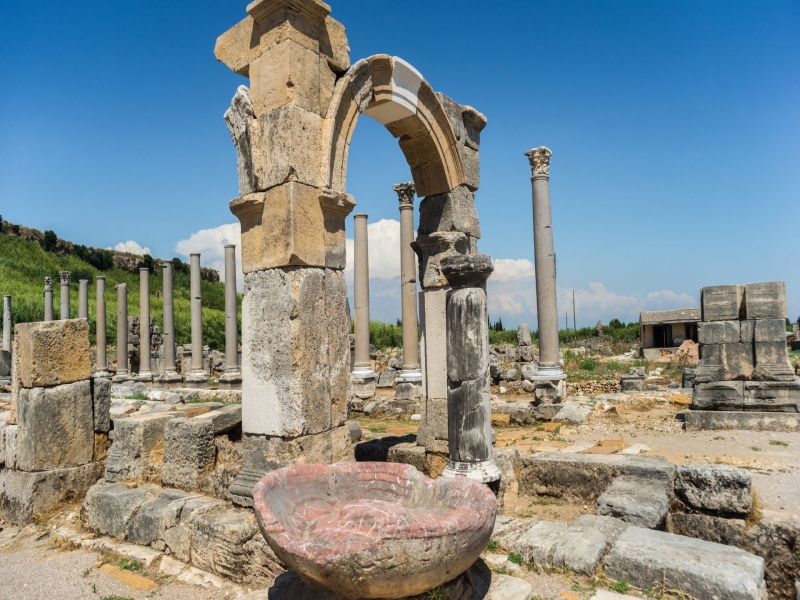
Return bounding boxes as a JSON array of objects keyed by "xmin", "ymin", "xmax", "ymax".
[{"xmin": 242, "ymin": 268, "xmax": 350, "ymax": 437}]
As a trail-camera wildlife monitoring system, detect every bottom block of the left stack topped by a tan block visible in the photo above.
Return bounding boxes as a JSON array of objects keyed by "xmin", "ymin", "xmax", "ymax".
[{"xmin": 0, "ymin": 462, "xmax": 103, "ymax": 525}]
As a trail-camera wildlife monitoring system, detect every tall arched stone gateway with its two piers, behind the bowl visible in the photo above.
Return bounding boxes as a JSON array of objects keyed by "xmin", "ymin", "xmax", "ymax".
[{"xmin": 215, "ymin": 0, "xmax": 486, "ymax": 504}]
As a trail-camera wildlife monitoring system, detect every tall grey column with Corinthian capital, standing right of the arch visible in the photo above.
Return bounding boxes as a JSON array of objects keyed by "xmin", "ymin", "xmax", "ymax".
[{"xmin": 525, "ymin": 146, "xmax": 566, "ymax": 381}]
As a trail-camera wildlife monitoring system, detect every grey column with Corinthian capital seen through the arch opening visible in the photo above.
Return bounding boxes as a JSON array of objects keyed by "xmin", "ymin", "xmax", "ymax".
[{"xmin": 392, "ymin": 183, "xmax": 422, "ymax": 384}]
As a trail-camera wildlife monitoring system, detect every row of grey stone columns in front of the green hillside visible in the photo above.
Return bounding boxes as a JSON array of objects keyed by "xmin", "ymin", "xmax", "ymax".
[{"xmin": 33, "ymin": 245, "xmax": 241, "ymax": 385}]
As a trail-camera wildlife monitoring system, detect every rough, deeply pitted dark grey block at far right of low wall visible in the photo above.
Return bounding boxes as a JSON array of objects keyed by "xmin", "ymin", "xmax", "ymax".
[{"xmin": 675, "ymin": 463, "xmax": 753, "ymax": 515}]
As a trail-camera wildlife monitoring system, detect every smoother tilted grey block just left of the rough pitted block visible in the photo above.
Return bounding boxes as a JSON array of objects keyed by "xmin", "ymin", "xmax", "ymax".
[{"xmin": 597, "ymin": 477, "xmax": 669, "ymax": 529}]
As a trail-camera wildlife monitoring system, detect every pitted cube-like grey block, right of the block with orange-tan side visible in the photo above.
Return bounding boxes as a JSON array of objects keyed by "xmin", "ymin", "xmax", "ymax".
[{"xmin": 161, "ymin": 418, "xmax": 217, "ymax": 490}]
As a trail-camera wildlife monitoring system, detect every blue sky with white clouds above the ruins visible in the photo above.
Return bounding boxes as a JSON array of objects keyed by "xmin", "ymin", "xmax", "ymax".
[{"xmin": 0, "ymin": 0, "xmax": 800, "ymax": 326}]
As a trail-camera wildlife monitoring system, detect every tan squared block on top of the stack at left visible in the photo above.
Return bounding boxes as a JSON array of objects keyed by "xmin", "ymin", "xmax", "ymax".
[{"xmin": 14, "ymin": 319, "xmax": 92, "ymax": 388}]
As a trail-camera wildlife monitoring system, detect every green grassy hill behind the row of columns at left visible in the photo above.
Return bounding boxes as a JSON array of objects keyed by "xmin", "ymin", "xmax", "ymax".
[{"xmin": 0, "ymin": 234, "xmax": 241, "ymax": 351}]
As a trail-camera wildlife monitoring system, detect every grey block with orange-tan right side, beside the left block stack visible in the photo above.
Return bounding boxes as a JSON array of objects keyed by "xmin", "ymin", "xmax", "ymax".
[{"xmin": 106, "ymin": 412, "xmax": 178, "ymax": 482}]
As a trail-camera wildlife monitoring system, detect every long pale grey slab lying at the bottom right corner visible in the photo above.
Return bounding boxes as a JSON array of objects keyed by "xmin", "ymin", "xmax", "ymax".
[{"xmin": 604, "ymin": 527, "xmax": 766, "ymax": 600}]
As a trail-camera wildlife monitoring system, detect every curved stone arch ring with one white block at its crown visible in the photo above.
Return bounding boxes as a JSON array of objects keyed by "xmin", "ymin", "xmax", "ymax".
[{"xmin": 322, "ymin": 54, "xmax": 466, "ymax": 197}]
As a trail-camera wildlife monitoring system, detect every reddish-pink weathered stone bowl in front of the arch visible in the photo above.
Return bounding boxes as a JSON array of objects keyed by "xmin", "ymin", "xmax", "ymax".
[{"xmin": 253, "ymin": 462, "xmax": 497, "ymax": 600}]
